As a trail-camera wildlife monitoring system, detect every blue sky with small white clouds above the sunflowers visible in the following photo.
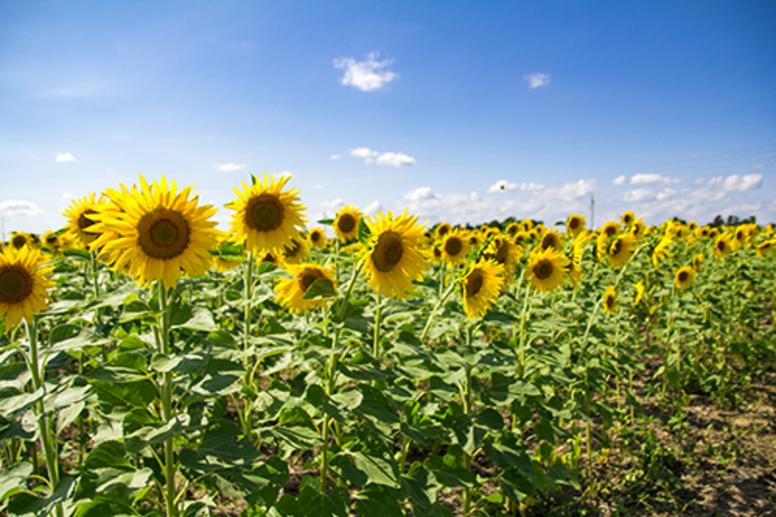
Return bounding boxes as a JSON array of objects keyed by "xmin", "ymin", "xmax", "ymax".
[{"xmin": 0, "ymin": 0, "xmax": 776, "ymax": 235}]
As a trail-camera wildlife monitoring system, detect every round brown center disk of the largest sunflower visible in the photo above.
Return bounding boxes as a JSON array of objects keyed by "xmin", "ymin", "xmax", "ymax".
[{"xmin": 138, "ymin": 208, "xmax": 191, "ymax": 260}]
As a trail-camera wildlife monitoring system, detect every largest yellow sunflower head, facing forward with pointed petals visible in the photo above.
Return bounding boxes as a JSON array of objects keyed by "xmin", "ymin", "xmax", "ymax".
[{"xmin": 90, "ymin": 176, "xmax": 219, "ymax": 289}]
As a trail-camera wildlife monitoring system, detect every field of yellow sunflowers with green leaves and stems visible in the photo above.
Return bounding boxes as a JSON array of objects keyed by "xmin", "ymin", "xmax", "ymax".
[{"xmin": 0, "ymin": 175, "xmax": 776, "ymax": 517}]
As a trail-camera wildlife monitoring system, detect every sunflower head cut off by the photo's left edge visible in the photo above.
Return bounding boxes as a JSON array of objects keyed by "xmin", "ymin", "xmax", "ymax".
[{"xmin": 0, "ymin": 246, "xmax": 53, "ymax": 331}]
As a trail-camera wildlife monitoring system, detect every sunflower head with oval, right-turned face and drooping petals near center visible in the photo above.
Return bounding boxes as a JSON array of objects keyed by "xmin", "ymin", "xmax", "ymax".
[{"xmin": 363, "ymin": 211, "xmax": 428, "ymax": 298}]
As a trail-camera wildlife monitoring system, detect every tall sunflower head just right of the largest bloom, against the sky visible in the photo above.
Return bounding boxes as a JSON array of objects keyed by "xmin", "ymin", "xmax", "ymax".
[{"xmin": 226, "ymin": 174, "xmax": 305, "ymax": 251}]
